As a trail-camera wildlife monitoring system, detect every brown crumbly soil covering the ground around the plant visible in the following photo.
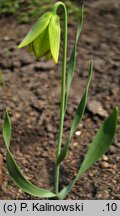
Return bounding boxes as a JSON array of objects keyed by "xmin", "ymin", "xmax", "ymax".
[{"xmin": 0, "ymin": 0, "xmax": 120, "ymax": 200}]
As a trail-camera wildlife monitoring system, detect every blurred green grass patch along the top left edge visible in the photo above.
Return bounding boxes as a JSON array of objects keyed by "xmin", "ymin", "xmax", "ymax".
[{"xmin": 0, "ymin": 0, "xmax": 87, "ymax": 23}]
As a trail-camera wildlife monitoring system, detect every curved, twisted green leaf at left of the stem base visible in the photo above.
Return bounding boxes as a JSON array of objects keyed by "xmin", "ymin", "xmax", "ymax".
[{"xmin": 3, "ymin": 111, "xmax": 56, "ymax": 197}]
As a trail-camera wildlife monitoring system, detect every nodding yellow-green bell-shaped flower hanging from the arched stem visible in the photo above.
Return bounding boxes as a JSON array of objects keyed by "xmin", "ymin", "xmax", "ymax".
[{"xmin": 18, "ymin": 12, "xmax": 60, "ymax": 64}]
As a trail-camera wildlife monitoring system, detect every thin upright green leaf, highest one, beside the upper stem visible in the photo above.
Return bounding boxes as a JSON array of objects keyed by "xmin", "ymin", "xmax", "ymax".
[{"xmin": 65, "ymin": 6, "xmax": 84, "ymax": 111}]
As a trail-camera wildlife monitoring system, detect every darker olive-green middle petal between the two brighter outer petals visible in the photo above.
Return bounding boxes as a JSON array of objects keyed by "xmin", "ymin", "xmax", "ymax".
[{"xmin": 32, "ymin": 27, "xmax": 50, "ymax": 58}]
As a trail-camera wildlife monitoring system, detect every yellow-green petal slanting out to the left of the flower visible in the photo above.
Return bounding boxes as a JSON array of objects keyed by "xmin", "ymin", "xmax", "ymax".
[{"xmin": 18, "ymin": 12, "xmax": 52, "ymax": 48}]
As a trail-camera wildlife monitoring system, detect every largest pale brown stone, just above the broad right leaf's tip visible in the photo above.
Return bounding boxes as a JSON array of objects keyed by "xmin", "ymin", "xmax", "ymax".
[{"xmin": 87, "ymin": 100, "xmax": 108, "ymax": 117}]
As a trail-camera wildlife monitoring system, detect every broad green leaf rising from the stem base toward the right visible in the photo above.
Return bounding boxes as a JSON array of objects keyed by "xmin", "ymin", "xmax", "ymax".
[{"xmin": 58, "ymin": 108, "xmax": 118, "ymax": 199}]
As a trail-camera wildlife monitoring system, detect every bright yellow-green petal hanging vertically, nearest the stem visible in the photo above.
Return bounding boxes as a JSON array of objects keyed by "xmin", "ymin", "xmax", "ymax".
[{"xmin": 49, "ymin": 14, "xmax": 60, "ymax": 64}]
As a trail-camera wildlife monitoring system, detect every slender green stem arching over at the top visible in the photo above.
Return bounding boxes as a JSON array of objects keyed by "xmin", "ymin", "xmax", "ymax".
[{"xmin": 53, "ymin": 2, "xmax": 67, "ymax": 195}]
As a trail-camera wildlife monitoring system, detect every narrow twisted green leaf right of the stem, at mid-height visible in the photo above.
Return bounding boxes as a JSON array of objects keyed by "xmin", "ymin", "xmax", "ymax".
[{"xmin": 57, "ymin": 61, "xmax": 93, "ymax": 164}]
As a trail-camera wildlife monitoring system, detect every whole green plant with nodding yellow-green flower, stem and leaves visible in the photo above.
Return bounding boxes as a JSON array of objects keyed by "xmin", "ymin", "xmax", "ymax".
[{"xmin": 3, "ymin": 2, "xmax": 118, "ymax": 199}]
